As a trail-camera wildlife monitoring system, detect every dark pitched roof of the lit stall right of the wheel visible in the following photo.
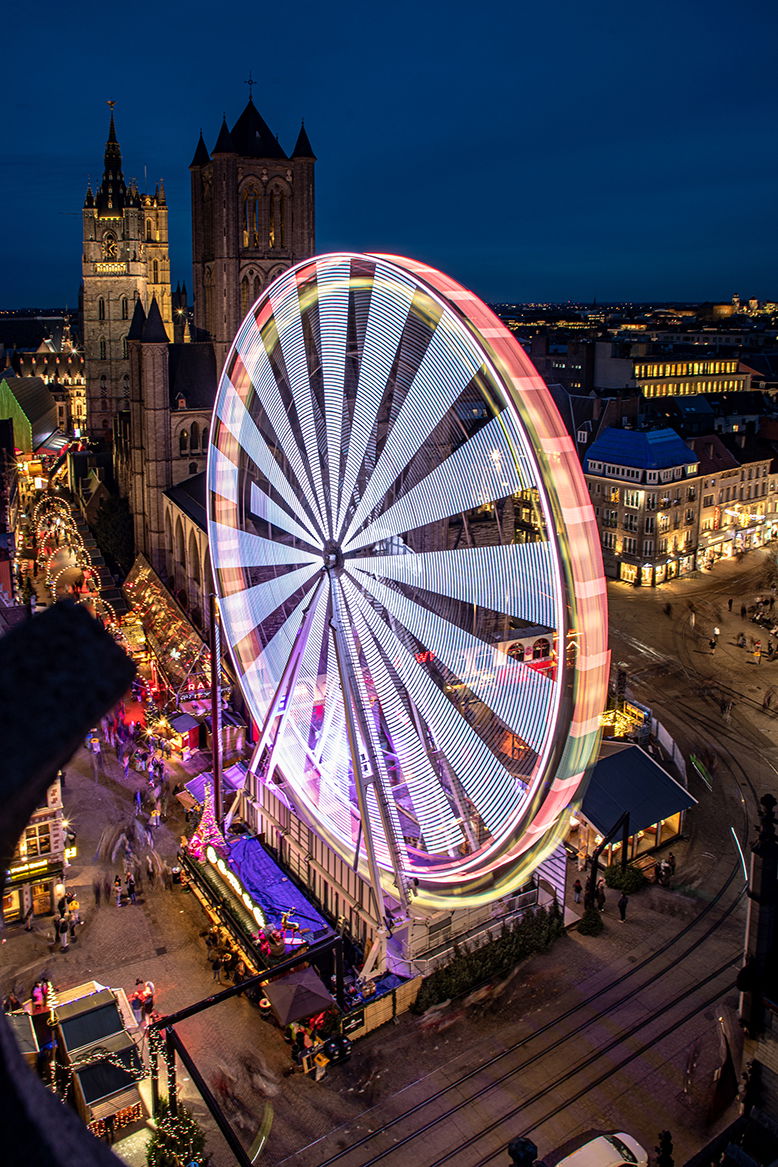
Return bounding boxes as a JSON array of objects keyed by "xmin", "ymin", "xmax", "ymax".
[{"xmin": 581, "ymin": 745, "xmax": 696, "ymax": 834}]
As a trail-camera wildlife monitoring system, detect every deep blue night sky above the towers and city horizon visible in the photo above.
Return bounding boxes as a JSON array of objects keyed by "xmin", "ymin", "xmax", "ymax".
[{"xmin": 0, "ymin": 0, "xmax": 778, "ymax": 307}]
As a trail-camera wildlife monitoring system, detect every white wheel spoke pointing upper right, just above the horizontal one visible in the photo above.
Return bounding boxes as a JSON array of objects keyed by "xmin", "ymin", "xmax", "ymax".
[{"xmin": 343, "ymin": 412, "xmax": 534, "ymax": 552}]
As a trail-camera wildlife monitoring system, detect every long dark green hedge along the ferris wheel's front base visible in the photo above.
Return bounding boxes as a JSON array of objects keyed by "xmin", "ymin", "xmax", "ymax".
[{"xmin": 413, "ymin": 903, "xmax": 565, "ymax": 1013}]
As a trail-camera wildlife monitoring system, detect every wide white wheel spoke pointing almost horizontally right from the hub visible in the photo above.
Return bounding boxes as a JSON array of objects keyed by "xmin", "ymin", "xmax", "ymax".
[{"xmin": 346, "ymin": 543, "xmax": 556, "ymax": 628}]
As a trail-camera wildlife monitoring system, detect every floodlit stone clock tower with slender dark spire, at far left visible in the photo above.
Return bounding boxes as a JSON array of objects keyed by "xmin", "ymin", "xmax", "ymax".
[{"xmin": 82, "ymin": 113, "xmax": 173, "ymax": 438}]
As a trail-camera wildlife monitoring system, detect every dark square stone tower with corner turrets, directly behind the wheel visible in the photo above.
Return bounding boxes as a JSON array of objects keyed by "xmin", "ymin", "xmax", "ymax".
[{"xmin": 190, "ymin": 97, "xmax": 316, "ymax": 371}]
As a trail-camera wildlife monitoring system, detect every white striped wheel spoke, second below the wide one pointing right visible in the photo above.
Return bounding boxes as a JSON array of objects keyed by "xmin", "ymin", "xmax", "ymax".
[{"xmin": 344, "ymin": 571, "xmax": 524, "ymax": 832}]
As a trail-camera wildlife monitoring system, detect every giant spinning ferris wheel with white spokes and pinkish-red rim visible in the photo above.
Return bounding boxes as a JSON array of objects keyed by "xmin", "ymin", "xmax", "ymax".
[{"xmin": 208, "ymin": 254, "xmax": 608, "ymax": 920}]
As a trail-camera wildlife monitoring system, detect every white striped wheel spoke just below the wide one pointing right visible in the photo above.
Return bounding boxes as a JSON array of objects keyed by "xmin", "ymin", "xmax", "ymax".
[{"xmin": 349, "ymin": 572, "xmax": 555, "ymax": 752}]
